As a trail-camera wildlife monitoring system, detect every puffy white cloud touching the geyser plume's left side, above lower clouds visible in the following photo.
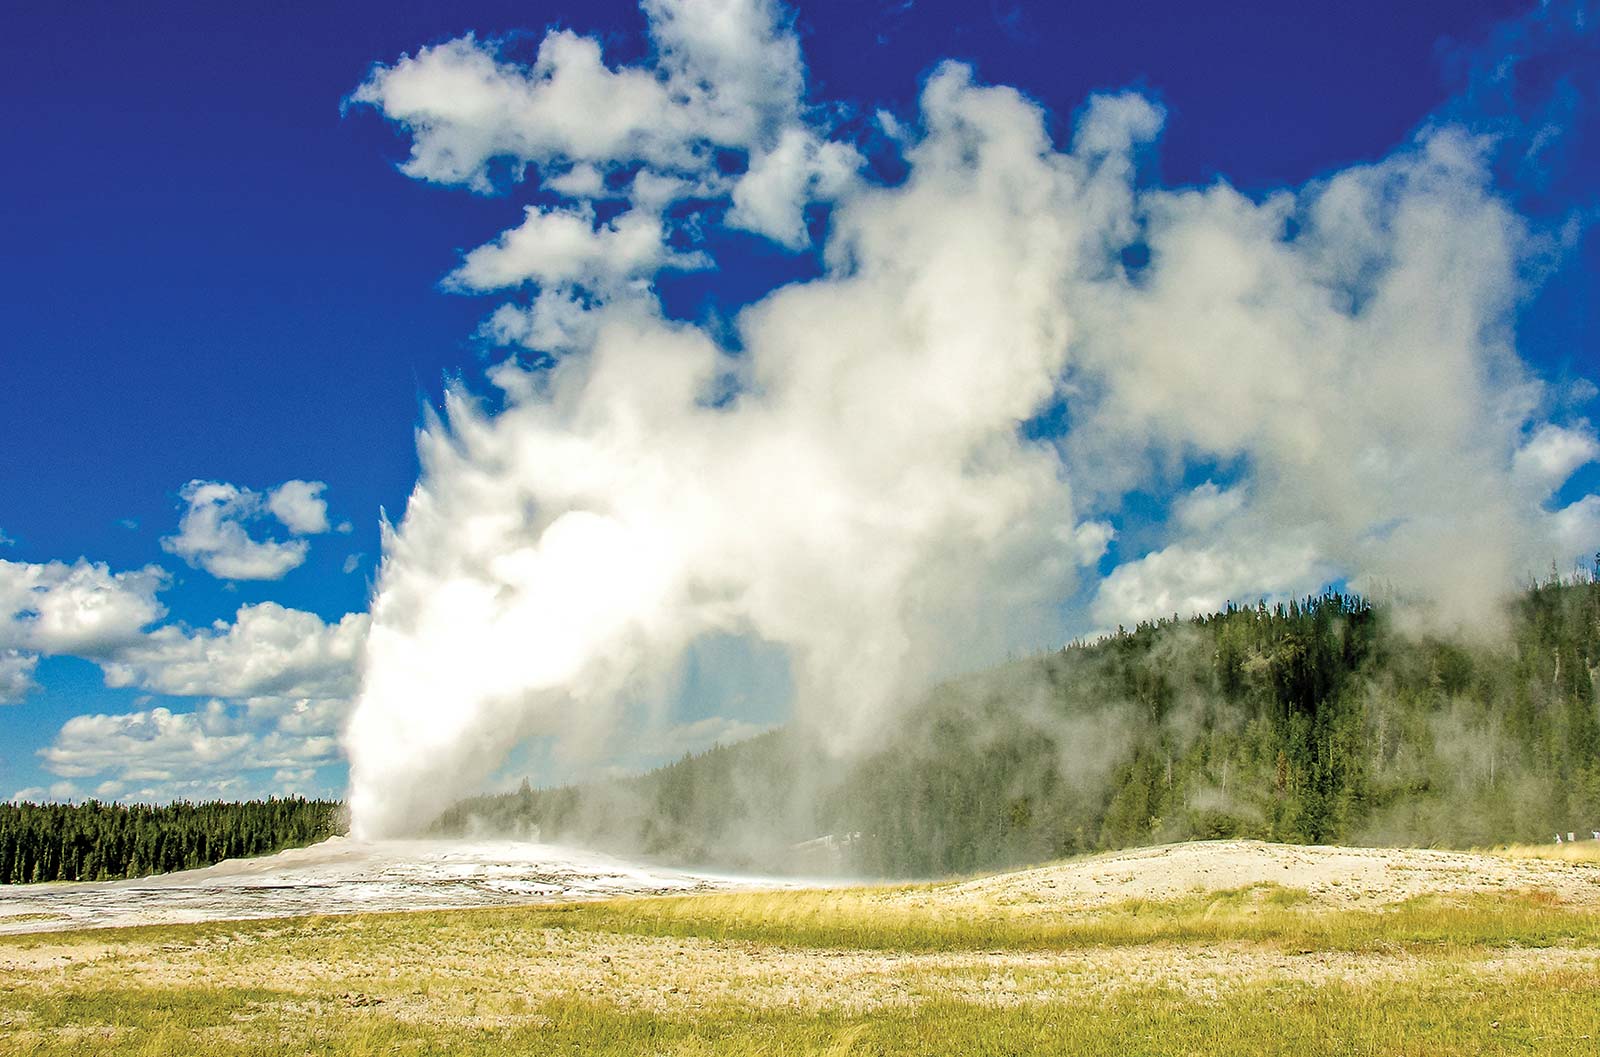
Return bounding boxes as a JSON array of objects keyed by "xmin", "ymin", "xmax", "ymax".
[{"xmin": 101, "ymin": 601, "xmax": 366, "ymax": 697}]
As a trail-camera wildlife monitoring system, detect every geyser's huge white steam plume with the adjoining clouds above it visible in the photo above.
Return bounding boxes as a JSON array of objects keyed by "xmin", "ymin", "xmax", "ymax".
[{"xmin": 346, "ymin": 0, "xmax": 1600, "ymax": 836}]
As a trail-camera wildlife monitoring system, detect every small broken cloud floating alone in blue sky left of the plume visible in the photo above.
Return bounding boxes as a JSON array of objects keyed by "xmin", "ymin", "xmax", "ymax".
[{"xmin": 162, "ymin": 480, "xmax": 328, "ymax": 580}]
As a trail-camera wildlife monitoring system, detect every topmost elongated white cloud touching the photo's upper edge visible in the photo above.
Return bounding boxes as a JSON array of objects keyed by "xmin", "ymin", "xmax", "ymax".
[{"xmin": 350, "ymin": 0, "xmax": 803, "ymax": 193}]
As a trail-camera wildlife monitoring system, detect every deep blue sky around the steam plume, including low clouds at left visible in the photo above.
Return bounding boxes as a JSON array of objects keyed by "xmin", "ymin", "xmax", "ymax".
[{"xmin": 0, "ymin": 0, "xmax": 1600, "ymax": 809}]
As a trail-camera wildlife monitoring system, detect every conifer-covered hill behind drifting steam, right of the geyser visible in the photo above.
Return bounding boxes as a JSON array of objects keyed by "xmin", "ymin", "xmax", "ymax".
[{"xmin": 438, "ymin": 577, "xmax": 1600, "ymax": 876}]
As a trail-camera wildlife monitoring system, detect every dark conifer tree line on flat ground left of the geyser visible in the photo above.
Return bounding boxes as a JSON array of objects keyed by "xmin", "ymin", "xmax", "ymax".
[{"xmin": 0, "ymin": 796, "xmax": 342, "ymax": 884}]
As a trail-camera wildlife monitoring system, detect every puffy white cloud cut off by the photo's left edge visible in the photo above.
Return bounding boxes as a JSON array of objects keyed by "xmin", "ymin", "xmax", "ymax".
[{"xmin": 0, "ymin": 558, "xmax": 166, "ymax": 659}]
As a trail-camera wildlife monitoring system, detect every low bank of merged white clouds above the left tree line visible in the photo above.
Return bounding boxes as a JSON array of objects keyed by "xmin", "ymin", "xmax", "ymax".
[{"xmin": 0, "ymin": 546, "xmax": 368, "ymax": 800}]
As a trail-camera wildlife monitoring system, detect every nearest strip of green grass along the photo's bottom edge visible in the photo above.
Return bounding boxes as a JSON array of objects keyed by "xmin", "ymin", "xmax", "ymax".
[{"xmin": 0, "ymin": 972, "xmax": 1600, "ymax": 1057}]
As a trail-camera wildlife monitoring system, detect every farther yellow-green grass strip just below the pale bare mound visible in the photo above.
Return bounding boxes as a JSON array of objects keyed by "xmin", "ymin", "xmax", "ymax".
[{"xmin": 15, "ymin": 884, "xmax": 1600, "ymax": 951}]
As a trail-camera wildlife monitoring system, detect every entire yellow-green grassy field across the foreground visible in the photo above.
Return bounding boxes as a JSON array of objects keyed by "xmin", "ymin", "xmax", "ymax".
[{"xmin": 0, "ymin": 886, "xmax": 1600, "ymax": 1055}]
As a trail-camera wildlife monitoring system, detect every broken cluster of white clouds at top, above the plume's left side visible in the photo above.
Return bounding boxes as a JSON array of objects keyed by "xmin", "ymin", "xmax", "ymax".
[{"xmin": 350, "ymin": 0, "xmax": 862, "ymax": 353}]
